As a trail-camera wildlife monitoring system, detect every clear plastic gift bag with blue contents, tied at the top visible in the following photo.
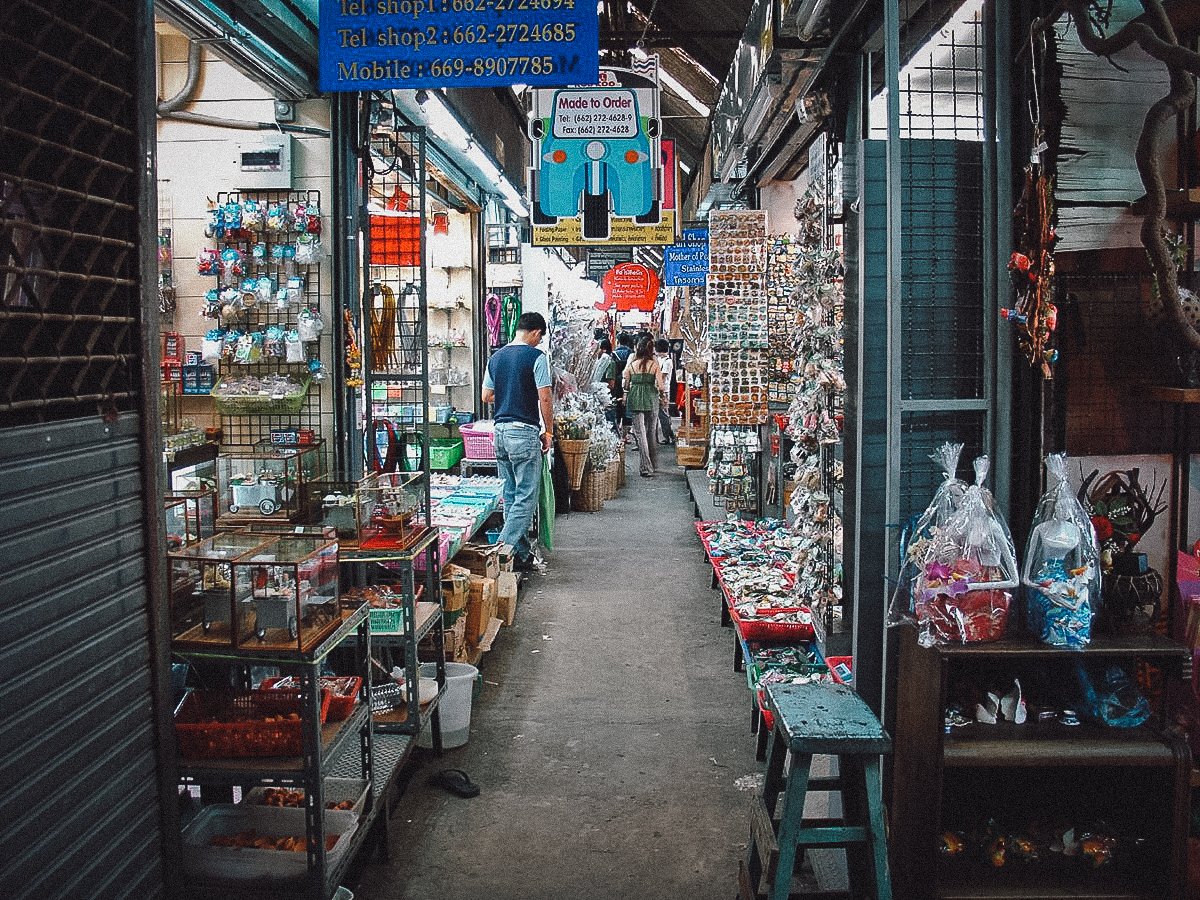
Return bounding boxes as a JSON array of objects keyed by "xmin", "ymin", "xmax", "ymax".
[{"xmin": 1021, "ymin": 454, "xmax": 1100, "ymax": 649}]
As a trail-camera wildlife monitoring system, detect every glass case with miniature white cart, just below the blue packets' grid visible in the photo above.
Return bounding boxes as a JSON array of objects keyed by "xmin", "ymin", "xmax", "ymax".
[{"xmin": 217, "ymin": 440, "xmax": 320, "ymax": 527}]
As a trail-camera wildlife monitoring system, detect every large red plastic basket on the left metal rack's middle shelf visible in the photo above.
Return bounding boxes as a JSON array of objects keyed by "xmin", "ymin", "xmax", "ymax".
[{"xmin": 175, "ymin": 690, "xmax": 330, "ymax": 760}]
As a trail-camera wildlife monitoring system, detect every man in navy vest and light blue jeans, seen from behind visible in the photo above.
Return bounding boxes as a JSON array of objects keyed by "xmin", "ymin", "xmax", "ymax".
[{"xmin": 482, "ymin": 312, "xmax": 554, "ymax": 571}]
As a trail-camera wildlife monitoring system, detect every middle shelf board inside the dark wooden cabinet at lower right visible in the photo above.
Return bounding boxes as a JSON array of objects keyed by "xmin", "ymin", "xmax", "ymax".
[{"xmin": 942, "ymin": 722, "xmax": 1175, "ymax": 768}]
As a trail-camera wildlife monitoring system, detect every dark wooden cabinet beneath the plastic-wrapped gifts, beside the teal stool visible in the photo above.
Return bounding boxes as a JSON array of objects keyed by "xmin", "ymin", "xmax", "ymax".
[{"xmin": 888, "ymin": 626, "xmax": 1192, "ymax": 900}]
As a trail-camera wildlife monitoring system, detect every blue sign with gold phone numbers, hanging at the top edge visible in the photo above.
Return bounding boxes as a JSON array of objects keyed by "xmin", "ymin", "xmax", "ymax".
[{"xmin": 318, "ymin": 0, "xmax": 600, "ymax": 91}]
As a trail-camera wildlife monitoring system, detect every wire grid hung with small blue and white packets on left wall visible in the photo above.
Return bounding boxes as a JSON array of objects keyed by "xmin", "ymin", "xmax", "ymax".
[{"xmin": 202, "ymin": 191, "xmax": 331, "ymax": 460}]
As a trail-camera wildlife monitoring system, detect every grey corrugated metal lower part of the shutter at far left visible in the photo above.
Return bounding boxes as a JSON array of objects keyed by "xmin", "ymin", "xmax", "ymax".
[{"xmin": 0, "ymin": 415, "xmax": 162, "ymax": 899}]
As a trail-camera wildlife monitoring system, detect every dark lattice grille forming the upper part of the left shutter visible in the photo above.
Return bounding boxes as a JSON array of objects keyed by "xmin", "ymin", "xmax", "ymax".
[{"xmin": 0, "ymin": 1, "xmax": 140, "ymax": 425}]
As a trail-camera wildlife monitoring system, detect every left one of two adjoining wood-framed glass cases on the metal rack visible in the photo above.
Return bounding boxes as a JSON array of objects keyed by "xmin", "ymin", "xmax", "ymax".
[{"xmin": 167, "ymin": 534, "xmax": 275, "ymax": 649}]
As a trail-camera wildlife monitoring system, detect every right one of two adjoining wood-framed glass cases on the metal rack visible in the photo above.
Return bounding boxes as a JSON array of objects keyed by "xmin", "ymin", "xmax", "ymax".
[{"xmin": 233, "ymin": 535, "xmax": 342, "ymax": 653}]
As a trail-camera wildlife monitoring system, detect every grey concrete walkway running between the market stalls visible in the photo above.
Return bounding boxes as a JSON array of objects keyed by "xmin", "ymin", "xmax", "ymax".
[{"xmin": 354, "ymin": 446, "xmax": 761, "ymax": 900}]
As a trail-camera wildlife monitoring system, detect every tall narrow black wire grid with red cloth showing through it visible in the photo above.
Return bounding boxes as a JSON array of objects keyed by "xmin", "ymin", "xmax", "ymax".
[{"xmin": 360, "ymin": 116, "xmax": 430, "ymax": 482}]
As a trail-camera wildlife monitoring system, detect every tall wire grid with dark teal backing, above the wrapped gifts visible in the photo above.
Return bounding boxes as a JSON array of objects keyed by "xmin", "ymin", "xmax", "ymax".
[{"xmin": 871, "ymin": 0, "xmax": 991, "ymax": 518}]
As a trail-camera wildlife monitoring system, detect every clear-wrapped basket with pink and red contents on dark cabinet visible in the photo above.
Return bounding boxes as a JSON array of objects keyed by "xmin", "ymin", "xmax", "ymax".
[{"xmin": 914, "ymin": 456, "xmax": 1018, "ymax": 647}]
